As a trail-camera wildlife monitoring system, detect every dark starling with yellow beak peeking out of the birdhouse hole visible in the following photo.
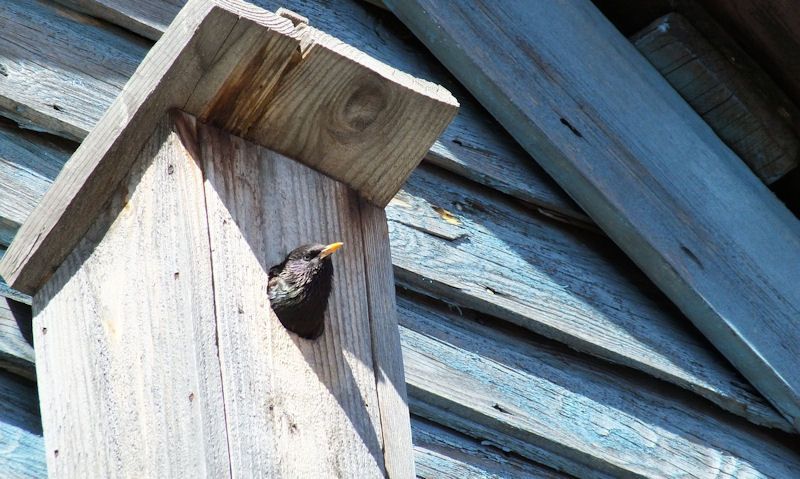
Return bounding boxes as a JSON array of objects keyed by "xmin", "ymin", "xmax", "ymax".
[{"xmin": 267, "ymin": 243, "xmax": 342, "ymax": 339}]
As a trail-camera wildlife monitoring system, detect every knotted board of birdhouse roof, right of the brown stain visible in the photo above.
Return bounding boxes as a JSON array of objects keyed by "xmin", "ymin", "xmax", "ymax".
[{"xmin": 241, "ymin": 27, "xmax": 458, "ymax": 207}]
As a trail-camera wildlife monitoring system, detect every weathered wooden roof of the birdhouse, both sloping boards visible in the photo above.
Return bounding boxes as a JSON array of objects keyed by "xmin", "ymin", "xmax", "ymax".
[{"xmin": 0, "ymin": 0, "xmax": 457, "ymax": 292}]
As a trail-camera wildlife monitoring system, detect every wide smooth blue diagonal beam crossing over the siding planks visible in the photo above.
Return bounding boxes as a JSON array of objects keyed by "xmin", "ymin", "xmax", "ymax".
[{"xmin": 387, "ymin": 0, "xmax": 800, "ymax": 429}]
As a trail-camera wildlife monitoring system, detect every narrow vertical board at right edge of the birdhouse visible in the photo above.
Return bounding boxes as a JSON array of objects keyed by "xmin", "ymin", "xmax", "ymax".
[{"xmin": 360, "ymin": 200, "xmax": 414, "ymax": 477}]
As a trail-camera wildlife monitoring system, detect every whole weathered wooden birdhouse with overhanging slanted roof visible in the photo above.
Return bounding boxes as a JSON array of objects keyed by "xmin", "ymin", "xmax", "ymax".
[{"xmin": 0, "ymin": 0, "xmax": 457, "ymax": 478}]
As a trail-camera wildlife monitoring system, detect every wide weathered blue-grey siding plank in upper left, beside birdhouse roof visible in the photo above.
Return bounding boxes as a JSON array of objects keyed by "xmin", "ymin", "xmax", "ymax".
[{"xmin": 0, "ymin": 0, "xmax": 148, "ymax": 141}]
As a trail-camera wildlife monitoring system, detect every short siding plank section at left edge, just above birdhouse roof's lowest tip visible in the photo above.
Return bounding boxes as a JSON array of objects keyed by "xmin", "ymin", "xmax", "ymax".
[{"xmin": 0, "ymin": 122, "xmax": 71, "ymax": 246}]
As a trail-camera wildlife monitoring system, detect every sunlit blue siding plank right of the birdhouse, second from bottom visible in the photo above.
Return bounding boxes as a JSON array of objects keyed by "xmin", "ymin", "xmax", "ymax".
[{"xmin": 398, "ymin": 297, "xmax": 800, "ymax": 477}]
